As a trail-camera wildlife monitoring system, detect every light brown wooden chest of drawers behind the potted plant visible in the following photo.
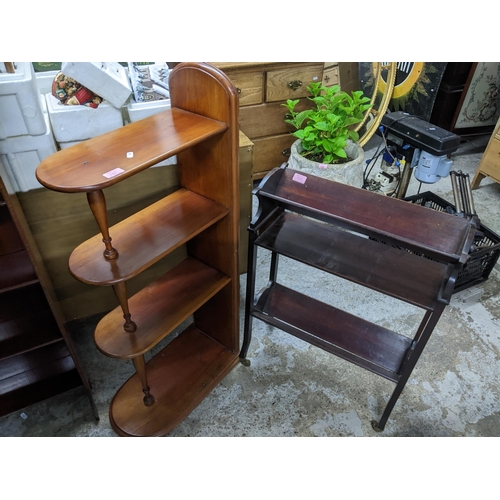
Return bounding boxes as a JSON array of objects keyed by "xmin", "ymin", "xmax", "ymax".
[{"xmin": 213, "ymin": 62, "xmax": 340, "ymax": 180}]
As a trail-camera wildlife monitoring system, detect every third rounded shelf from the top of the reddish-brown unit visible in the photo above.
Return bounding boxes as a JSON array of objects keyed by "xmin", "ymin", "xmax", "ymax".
[{"xmin": 94, "ymin": 257, "xmax": 231, "ymax": 359}]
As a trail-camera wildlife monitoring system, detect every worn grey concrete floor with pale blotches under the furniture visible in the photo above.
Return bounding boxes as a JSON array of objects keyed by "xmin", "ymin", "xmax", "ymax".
[{"xmin": 0, "ymin": 137, "xmax": 500, "ymax": 437}]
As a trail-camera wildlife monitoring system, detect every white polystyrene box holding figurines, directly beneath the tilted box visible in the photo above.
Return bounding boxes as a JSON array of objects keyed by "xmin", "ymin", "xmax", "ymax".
[{"xmin": 45, "ymin": 93, "xmax": 123, "ymax": 143}]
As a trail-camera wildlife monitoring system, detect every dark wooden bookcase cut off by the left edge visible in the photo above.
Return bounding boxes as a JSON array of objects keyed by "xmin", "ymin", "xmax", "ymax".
[{"xmin": 0, "ymin": 178, "xmax": 98, "ymax": 419}]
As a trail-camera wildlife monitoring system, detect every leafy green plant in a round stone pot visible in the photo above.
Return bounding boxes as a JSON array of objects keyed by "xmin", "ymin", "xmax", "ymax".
[{"xmin": 283, "ymin": 82, "xmax": 370, "ymax": 187}]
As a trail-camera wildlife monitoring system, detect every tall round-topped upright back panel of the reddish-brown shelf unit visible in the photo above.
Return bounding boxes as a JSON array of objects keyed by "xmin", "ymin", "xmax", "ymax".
[{"xmin": 169, "ymin": 63, "xmax": 240, "ymax": 352}]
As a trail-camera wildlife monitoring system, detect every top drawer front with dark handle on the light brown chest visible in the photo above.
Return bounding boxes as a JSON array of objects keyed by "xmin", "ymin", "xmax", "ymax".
[{"xmin": 266, "ymin": 63, "xmax": 323, "ymax": 102}]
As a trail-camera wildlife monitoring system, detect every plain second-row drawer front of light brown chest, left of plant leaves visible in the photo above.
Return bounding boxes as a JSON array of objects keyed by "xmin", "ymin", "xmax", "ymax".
[{"xmin": 240, "ymin": 98, "xmax": 311, "ymax": 140}]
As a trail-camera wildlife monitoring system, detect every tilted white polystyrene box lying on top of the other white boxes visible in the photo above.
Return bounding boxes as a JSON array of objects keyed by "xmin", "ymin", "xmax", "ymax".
[{"xmin": 61, "ymin": 62, "xmax": 132, "ymax": 108}]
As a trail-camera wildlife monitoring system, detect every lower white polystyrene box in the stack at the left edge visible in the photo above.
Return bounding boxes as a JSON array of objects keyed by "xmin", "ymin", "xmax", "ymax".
[{"xmin": 0, "ymin": 105, "xmax": 57, "ymax": 192}]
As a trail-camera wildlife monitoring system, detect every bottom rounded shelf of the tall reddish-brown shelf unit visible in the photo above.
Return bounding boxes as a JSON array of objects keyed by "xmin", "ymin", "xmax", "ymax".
[{"xmin": 109, "ymin": 325, "xmax": 239, "ymax": 436}]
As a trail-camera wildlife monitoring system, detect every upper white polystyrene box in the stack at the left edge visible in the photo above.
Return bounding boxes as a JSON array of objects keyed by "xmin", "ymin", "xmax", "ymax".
[{"xmin": 0, "ymin": 62, "xmax": 47, "ymax": 140}]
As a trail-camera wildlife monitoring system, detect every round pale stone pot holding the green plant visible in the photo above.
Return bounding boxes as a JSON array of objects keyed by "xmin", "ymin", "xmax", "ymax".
[{"xmin": 288, "ymin": 139, "xmax": 365, "ymax": 188}]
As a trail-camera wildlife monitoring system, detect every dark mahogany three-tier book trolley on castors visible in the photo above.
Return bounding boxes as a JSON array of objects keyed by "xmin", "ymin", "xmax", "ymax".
[{"xmin": 240, "ymin": 167, "xmax": 475, "ymax": 431}]
